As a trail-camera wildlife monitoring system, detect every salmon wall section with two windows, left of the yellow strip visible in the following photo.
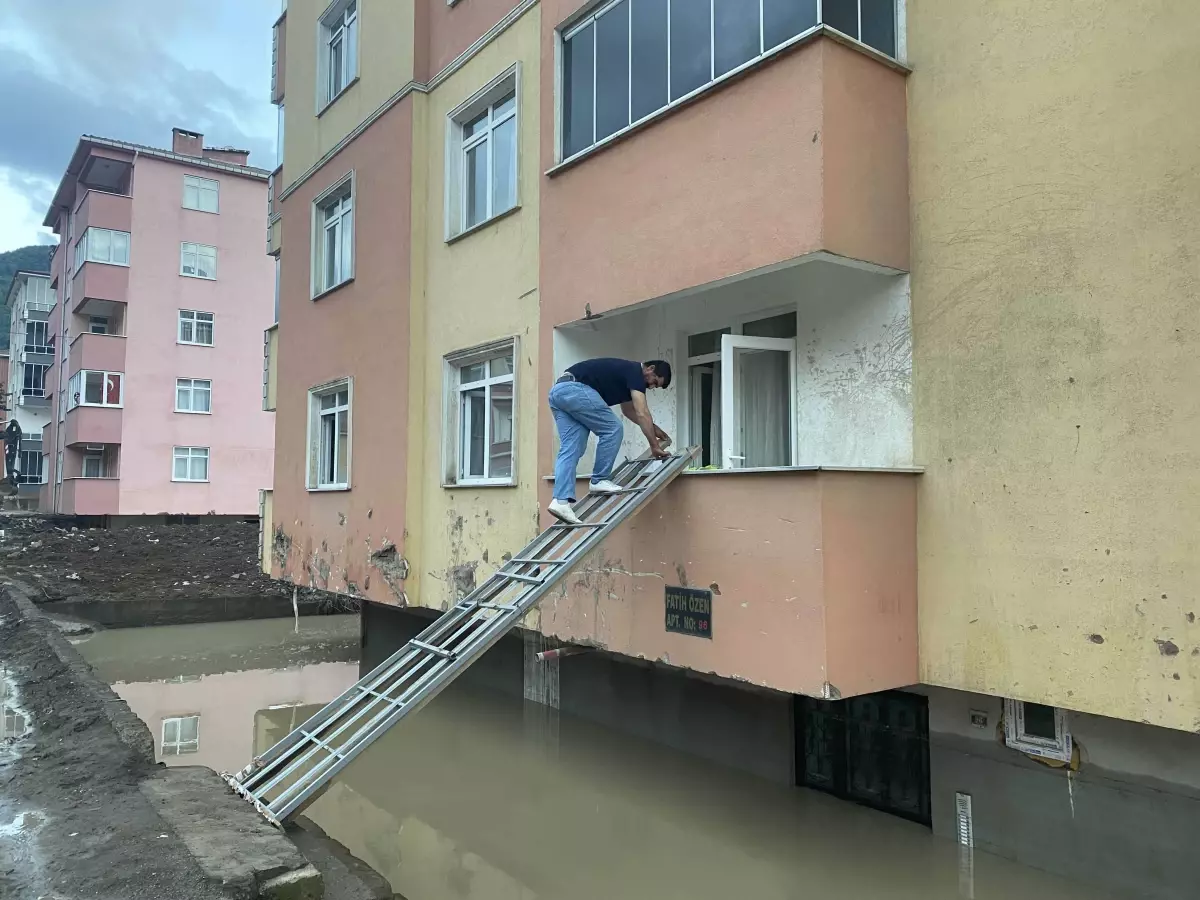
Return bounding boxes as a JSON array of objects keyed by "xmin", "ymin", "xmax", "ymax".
[{"xmin": 273, "ymin": 98, "xmax": 413, "ymax": 602}]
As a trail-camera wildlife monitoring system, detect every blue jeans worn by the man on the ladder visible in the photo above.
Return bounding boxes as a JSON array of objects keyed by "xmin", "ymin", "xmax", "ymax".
[{"xmin": 550, "ymin": 382, "xmax": 625, "ymax": 500}]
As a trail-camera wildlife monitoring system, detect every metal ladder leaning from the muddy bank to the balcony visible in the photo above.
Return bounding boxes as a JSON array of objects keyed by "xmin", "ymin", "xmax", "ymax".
[{"xmin": 221, "ymin": 450, "xmax": 695, "ymax": 827}]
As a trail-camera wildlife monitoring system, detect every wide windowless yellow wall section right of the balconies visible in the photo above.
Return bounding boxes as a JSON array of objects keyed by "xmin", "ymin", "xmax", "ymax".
[{"xmin": 908, "ymin": 0, "xmax": 1200, "ymax": 731}]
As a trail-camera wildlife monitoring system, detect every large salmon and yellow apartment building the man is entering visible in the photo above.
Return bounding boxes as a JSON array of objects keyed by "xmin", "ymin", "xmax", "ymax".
[{"xmin": 263, "ymin": 0, "xmax": 1200, "ymax": 898}]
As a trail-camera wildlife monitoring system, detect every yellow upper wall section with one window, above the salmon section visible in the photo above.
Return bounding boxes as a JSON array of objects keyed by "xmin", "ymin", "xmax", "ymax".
[{"xmin": 282, "ymin": 0, "xmax": 424, "ymax": 187}]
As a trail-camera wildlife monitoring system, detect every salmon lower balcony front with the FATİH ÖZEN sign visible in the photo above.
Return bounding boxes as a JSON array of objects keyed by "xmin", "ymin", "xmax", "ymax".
[{"xmin": 541, "ymin": 472, "xmax": 917, "ymax": 696}]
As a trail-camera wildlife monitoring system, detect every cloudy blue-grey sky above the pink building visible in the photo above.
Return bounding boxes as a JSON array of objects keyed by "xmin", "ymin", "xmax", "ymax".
[{"xmin": 0, "ymin": 0, "xmax": 280, "ymax": 251}]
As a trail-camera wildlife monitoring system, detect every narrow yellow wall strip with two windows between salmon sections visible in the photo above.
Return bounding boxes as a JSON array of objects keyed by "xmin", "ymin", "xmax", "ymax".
[{"xmin": 403, "ymin": 7, "xmax": 545, "ymax": 608}]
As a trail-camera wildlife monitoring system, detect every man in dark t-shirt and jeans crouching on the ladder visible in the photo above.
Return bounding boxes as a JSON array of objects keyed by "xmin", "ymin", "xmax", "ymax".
[{"xmin": 547, "ymin": 358, "xmax": 671, "ymax": 524}]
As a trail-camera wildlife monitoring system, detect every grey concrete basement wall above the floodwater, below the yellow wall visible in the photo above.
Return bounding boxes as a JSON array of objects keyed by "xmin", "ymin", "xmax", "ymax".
[{"xmin": 914, "ymin": 688, "xmax": 1200, "ymax": 900}]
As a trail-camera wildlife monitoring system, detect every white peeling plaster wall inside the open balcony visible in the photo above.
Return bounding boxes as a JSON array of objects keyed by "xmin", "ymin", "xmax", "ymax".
[{"xmin": 554, "ymin": 260, "xmax": 912, "ymax": 474}]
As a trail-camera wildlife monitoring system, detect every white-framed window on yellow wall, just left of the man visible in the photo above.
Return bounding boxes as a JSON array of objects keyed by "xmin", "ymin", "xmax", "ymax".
[{"xmin": 445, "ymin": 338, "xmax": 517, "ymax": 485}]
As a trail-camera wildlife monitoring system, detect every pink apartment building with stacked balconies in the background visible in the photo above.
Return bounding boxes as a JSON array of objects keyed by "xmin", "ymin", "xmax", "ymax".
[{"xmin": 42, "ymin": 128, "xmax": 274, "ymax": 517}]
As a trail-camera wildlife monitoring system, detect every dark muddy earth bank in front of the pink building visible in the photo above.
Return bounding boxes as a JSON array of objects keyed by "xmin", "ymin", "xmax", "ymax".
[{"xmin": 0, "ymin": 515, "xmax": 292, "ymax": 602}]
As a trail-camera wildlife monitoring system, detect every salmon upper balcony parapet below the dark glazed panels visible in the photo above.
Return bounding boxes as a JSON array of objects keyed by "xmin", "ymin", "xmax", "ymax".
[{"xmin": 539, "ymin": 30, "xmax": 908, "ymax": 325}]
